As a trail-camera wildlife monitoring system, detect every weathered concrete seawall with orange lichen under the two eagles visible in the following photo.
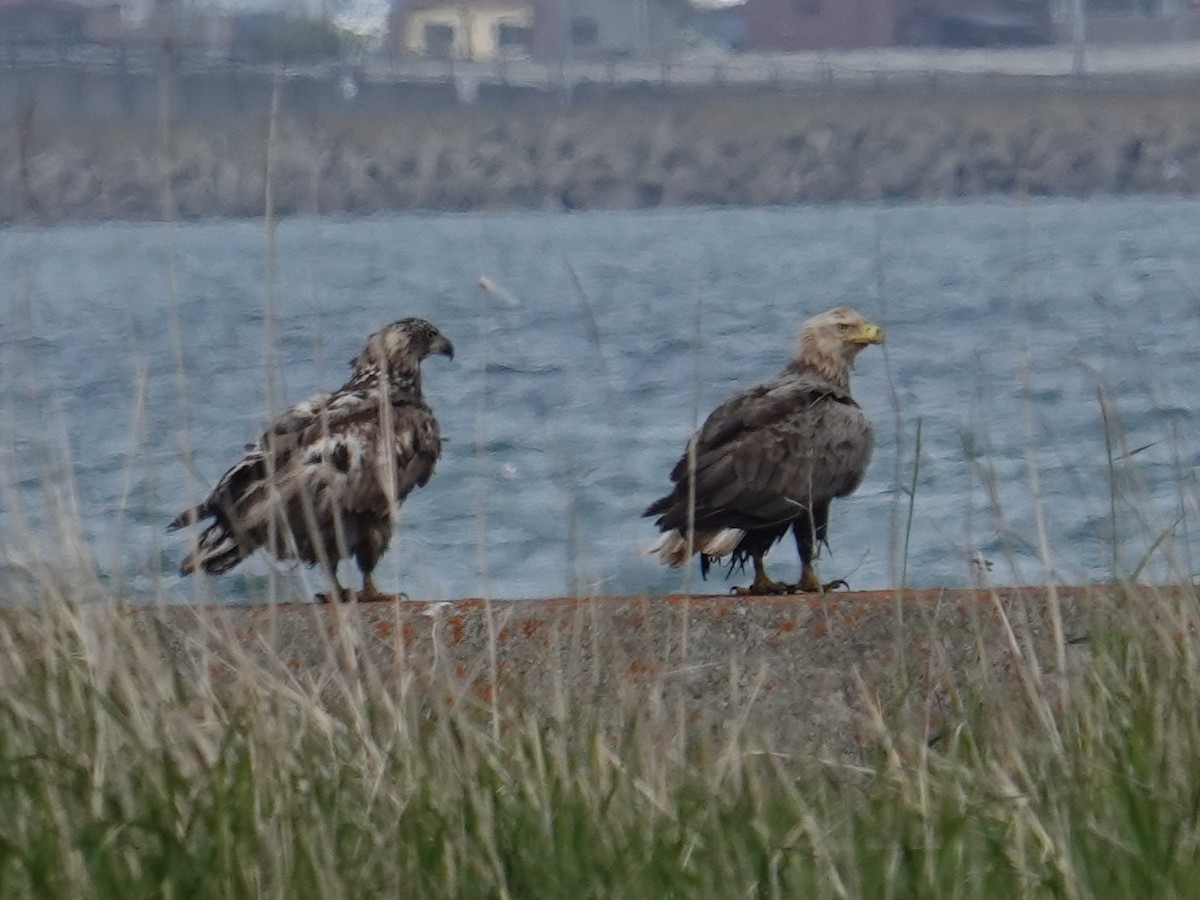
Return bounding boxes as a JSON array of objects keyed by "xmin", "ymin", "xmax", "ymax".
[{"xmin": 112, "ymin": 588, "xmax": 1123, "ymax": 761}]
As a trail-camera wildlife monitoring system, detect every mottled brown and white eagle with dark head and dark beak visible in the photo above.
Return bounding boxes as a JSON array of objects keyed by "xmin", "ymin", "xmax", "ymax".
[{"xmin": 167, "ymin": 318, "xmax": 454, "ymax": 600}]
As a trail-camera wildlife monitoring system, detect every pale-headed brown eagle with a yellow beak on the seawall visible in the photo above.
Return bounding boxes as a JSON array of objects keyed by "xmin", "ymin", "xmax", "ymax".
[{"xmin": 643, "ymin": 307, "xmax": 883, "ymax": 595}]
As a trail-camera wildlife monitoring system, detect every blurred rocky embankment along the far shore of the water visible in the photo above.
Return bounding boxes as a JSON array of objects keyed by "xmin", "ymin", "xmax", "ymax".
[{"xmin": 0, "ymin": 79, "xmax": 1200, "ymax": 223}]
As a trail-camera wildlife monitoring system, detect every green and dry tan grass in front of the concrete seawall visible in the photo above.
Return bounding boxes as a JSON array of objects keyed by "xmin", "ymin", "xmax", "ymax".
[{"xmin": 0, "ymin": 585, "xmax": 1200, "ymax": 900}]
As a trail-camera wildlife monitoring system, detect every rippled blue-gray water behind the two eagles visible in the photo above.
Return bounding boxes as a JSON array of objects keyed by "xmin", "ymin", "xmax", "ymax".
[{"xmin": 0, "ymin": 199, "xmax": 1200, "ymax": 598}]
